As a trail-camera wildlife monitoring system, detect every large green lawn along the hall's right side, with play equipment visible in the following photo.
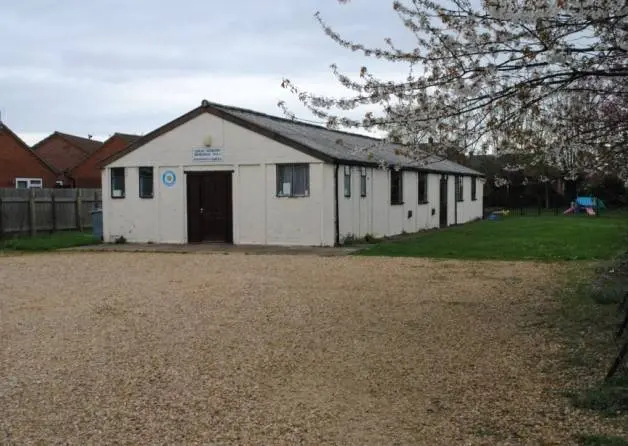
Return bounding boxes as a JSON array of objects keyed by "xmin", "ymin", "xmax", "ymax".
[{"xmin": 357, "ymin": 212, "xmax": 628, "ymax": 261}]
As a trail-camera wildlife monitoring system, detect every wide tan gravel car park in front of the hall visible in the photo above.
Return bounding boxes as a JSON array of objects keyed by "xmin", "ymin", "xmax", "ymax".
[{"xmin": 0, "ymin": 253, "xmax": 628, "ymax": 445}]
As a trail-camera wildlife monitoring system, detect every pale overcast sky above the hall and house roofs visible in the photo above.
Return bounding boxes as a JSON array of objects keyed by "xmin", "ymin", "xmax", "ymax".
[{"xmin": 0, "ymin": 0, "xmax": 406, "ymax": 144}]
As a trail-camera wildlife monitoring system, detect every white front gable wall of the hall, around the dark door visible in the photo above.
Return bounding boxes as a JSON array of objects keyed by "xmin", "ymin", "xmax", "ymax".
[{"xmin": 103, "ymin": 113, "xmax": 335, "ymax": 245}]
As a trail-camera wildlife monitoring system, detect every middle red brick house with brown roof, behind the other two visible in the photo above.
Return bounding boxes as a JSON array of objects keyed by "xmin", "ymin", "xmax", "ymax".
[{"xmin": 33, "ymin": 132, "xmax": 103, "ymax": 187}]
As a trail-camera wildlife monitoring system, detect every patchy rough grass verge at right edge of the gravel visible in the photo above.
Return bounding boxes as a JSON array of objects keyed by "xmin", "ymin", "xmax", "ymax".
[{"xmin": 555, "ymin": 247, "xmax": 628, "ymax": 446}]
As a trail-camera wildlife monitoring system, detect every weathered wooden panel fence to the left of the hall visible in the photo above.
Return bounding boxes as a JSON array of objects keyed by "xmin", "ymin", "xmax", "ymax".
[{"xmin": 0, "ymin": 188, "xmax": 102, "ymax": 237}]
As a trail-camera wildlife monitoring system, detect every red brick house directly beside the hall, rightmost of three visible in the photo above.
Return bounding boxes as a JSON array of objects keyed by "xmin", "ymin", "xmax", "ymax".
[{"xmin": 68, "ymin": 133, "xmax": 140, "ymax": 188}]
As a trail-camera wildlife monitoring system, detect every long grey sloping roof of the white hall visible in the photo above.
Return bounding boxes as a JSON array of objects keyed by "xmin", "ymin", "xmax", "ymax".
[{"xmin": 210, "ymin": 103, "xmax": 483, "ymax": 175}]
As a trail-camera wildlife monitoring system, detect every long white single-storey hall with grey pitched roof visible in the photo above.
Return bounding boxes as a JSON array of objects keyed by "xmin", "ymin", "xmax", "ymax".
[{"xmin": 102, "ymin": 101, "xmax": 484, "ymax": 246}]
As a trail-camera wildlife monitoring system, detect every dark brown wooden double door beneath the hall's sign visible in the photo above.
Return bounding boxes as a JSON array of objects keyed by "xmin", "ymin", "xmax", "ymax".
[{"xmin": 187, "ymin": 172, "xmax": 233, "ymax": 243}]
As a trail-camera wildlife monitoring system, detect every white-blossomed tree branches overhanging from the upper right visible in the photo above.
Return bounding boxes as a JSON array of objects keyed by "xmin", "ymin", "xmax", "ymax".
[{"xmin": 280, "ymin": 0, "xmax": 628, "ymax": 178}]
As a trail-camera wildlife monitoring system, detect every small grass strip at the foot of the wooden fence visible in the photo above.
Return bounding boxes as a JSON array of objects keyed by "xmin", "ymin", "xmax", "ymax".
[{"xmin": 0, "ymin": 232, "xmax": 100, "ymax": 252}]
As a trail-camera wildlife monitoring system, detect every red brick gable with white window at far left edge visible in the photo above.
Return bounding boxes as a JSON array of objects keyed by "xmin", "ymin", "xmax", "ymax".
[{"xmin": 0, "ymin": 122, "xmax": 57, "ymax": 188}]
